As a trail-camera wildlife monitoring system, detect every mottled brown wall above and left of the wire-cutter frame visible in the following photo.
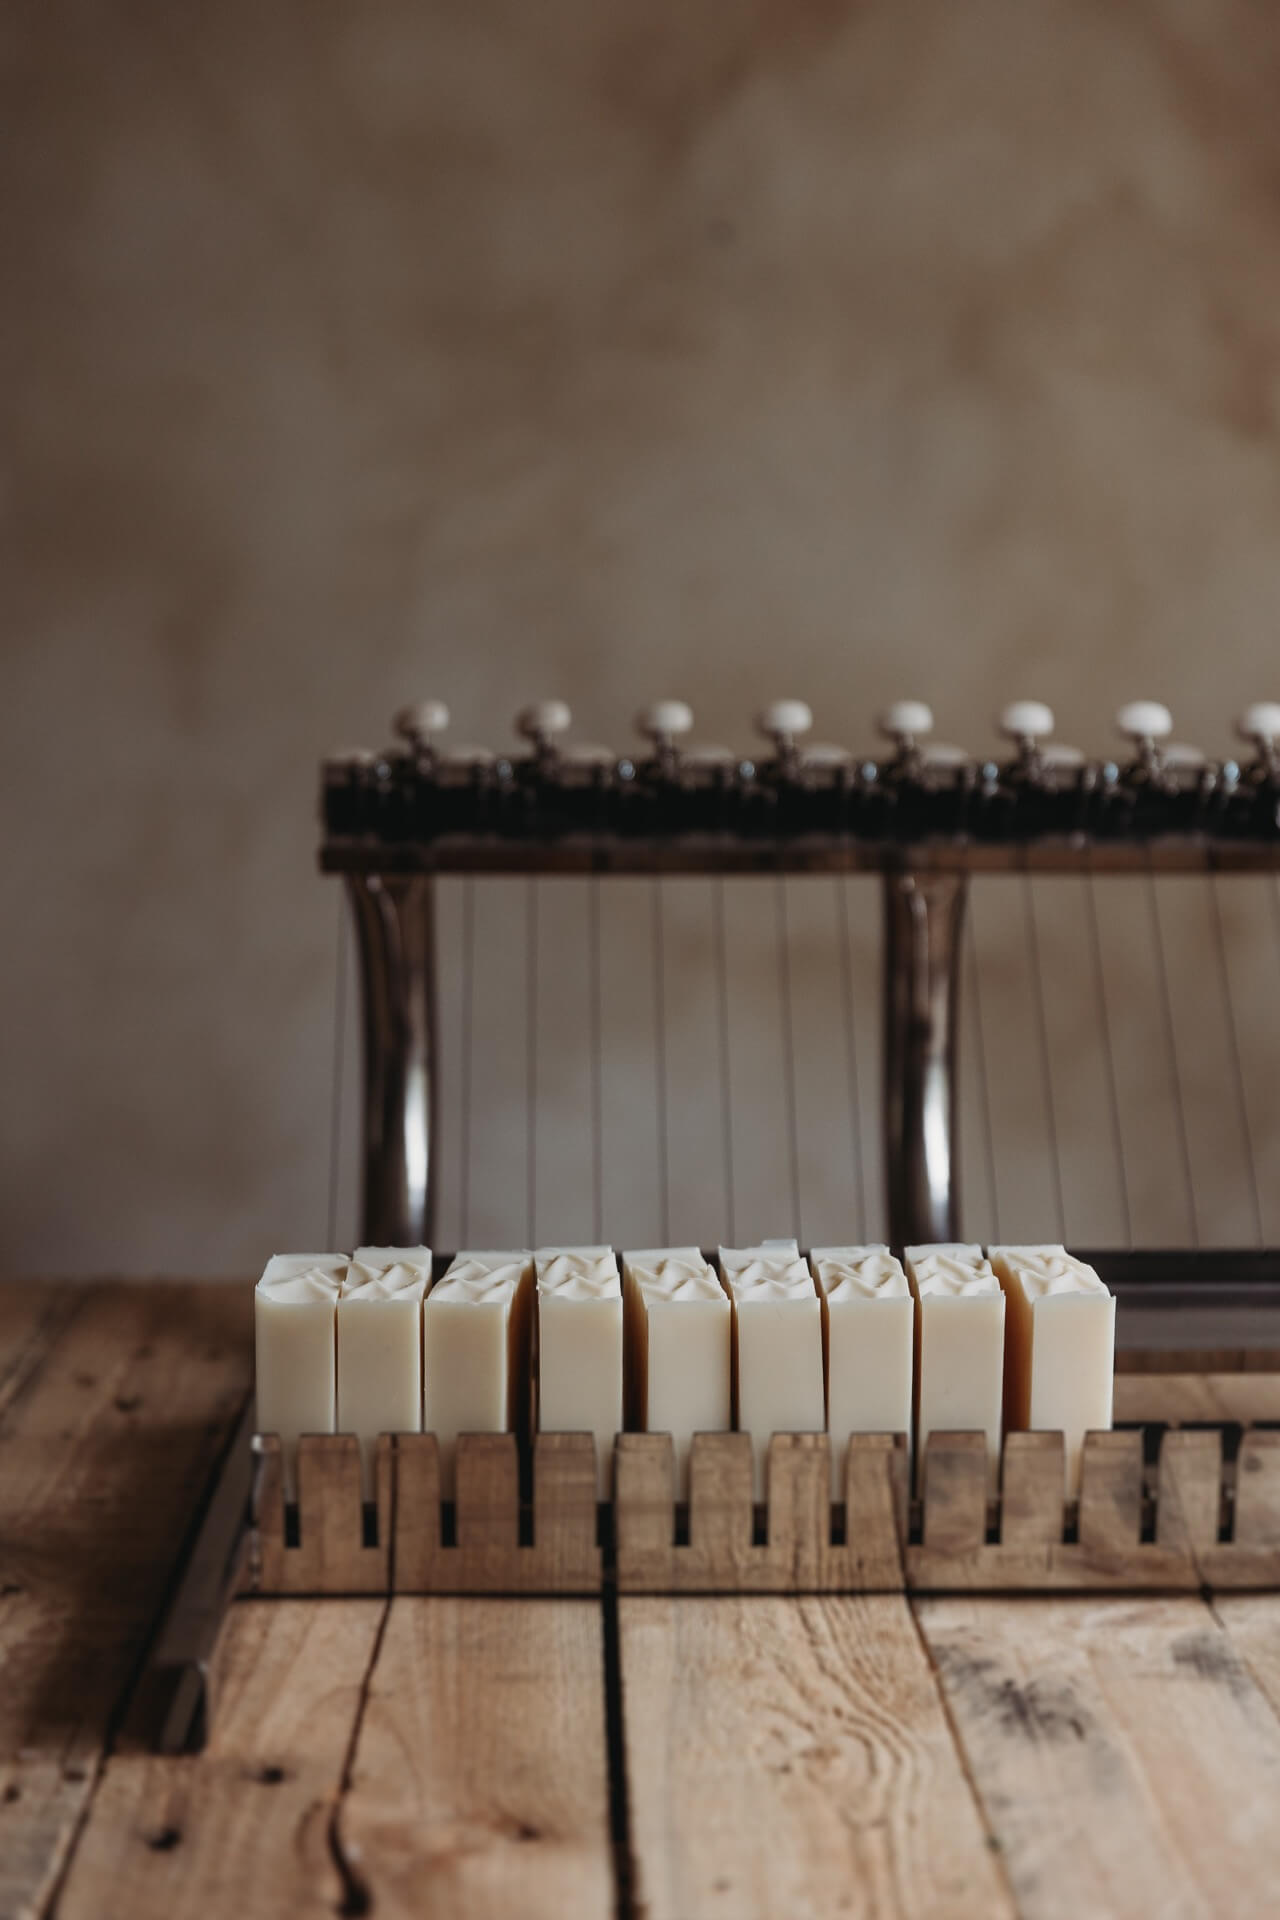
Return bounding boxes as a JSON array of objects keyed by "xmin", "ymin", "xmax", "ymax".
[{"xmin": 0, "ymin": 11, "xmax": 1280, "ymax": 1271}]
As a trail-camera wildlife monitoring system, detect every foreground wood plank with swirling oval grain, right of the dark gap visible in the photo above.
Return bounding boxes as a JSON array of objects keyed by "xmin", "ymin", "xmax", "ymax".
[{"xmin": 618, "ymin": 1596, "xmax": 1013, "ymax": 1920}]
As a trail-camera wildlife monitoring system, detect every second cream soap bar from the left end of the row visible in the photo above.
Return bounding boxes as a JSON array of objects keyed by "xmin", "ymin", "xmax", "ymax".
[{"xmin": 338, "ymin": 1246, "xmax": 432, "ymax": 1500}]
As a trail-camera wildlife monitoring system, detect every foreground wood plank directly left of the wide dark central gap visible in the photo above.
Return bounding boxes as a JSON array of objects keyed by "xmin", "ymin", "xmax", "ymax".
[{"xmin": 340, "ymin": 1597, "xmax": 614, "ymax": 1920}]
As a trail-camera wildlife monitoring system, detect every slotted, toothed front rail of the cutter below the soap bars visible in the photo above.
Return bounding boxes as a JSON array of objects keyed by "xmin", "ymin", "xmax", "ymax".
[{"xmin": 248, "ymin": 1427, "xmax": 1280, "ymax": 1594}]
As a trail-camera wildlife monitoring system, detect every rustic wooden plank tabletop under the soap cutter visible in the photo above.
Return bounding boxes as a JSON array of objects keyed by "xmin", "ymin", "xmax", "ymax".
[{"xmin": 0, "ymin": 1281, "xmax": 1280, "ymax": 1920}]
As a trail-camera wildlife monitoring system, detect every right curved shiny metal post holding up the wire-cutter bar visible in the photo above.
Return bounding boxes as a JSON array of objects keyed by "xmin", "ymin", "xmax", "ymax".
[{"xmin": 885, "ymin": 872, "xmax": 967, "ymax": 1246}]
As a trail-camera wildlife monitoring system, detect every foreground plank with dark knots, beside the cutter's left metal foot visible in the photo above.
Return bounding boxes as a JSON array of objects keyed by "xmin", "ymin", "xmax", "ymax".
[{"xmin": 55, "ymin": 1599, "xmax": 384, "ymax": 1920}]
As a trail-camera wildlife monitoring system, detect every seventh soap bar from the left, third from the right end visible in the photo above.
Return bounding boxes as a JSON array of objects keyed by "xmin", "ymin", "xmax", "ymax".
[{"xmin": 810, "ymin": 1246, "xmax": 915, "ymax": 1500}]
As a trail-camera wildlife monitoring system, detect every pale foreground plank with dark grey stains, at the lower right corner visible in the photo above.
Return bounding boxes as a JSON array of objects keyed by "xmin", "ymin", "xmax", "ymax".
[{"xmin": 915, "ymin": 1597, "xmax": 1280, "ymax": 1920}]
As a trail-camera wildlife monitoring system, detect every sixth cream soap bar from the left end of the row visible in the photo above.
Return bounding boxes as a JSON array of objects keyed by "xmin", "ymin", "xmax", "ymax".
[{"xmin": 720, "ymin": 1240, "xmax": 825, "ymax": 1500}]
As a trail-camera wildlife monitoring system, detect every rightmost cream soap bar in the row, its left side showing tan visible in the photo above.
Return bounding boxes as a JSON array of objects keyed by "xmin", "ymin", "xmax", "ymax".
[{"xmin": 990, "ymin": 1246, "xmax": 1115, "ymax": 1500}]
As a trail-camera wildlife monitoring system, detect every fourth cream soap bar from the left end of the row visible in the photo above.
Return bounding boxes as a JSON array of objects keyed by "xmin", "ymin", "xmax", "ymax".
[{"xmin": 535, "ymin": 1246, "xmax": 622, "ymax": 1500}]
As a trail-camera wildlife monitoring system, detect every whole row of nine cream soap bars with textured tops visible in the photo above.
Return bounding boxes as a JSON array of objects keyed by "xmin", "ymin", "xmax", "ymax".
[{"xmin": 255, "ymin": 1240, "xmax": 1115, "ymax": 1500}]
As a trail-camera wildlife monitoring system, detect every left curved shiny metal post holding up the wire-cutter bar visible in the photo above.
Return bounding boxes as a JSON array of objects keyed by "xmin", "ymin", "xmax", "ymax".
[{"xmin": 345, "ymin": 874, "xmax": 436, "ymax": 1246}]
